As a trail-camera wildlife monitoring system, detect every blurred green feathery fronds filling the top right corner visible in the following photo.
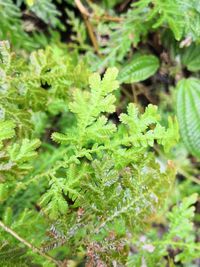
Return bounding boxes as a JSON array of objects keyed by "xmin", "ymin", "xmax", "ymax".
[{"xmin": 84, "ymin": 0, "xmax": 200, "ymax": 69}]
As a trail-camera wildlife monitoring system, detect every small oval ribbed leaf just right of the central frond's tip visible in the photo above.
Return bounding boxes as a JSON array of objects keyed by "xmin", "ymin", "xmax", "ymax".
[{"xmin": 119, "ymin": 55, "xmax": 159, "ymax": 83}]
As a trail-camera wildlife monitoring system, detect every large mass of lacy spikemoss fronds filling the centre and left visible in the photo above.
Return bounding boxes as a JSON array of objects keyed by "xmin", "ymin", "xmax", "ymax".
[{"xmin": 0, "ymin": 42, "xmax": 178, "ymax": 264}]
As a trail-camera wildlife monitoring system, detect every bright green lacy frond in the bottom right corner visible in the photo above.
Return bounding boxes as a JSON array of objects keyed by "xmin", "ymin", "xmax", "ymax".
[{"xmin": 128, "ymin": 194, "xmax": 200, "ymax": 267}]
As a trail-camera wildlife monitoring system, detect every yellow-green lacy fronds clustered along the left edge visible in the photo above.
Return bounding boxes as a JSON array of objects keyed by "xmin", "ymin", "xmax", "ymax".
[{"xmin": 0, "ymin": 41, "xmax": 88, "ymax": 205}]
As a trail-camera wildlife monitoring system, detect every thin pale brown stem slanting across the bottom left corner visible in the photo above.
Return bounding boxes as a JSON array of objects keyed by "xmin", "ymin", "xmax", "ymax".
[{"xmin": 0, "ymin": 221, "xmax": 61, "ymax": 266}]
